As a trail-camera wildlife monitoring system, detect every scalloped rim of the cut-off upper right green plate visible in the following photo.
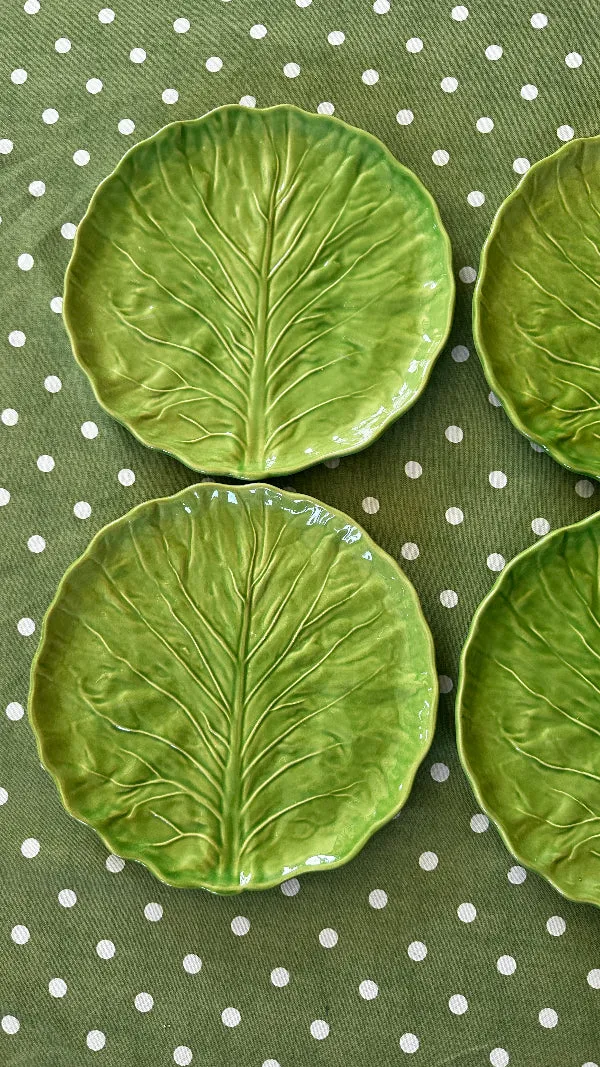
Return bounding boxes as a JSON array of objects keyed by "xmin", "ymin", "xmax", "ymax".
[{"xmin": 472, "ymin": 133, "xmax": 600, "ymax": 480}]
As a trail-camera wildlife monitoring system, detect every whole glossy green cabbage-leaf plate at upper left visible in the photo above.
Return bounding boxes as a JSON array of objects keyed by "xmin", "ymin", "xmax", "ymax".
[{"xmin": 64, "ymin": 106, "xmax": 454, "ymax": 480}]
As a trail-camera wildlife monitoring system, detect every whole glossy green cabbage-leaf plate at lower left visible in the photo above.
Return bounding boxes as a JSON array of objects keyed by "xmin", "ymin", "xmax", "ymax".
[{"xmin": 30, "ymin": 482, "xmax": 437, "ymax": 893}]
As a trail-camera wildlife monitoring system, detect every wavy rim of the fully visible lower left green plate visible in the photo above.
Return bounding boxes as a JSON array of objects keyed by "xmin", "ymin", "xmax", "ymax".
[{"xmin": 27, "ymin": 479, "xmax": 439, "ymax": 896}]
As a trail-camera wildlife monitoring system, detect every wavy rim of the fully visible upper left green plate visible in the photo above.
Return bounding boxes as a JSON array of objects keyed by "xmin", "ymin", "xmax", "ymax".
[{"xmin": 62, "ymin": 103, "xmax": 456, "ymax": 483}]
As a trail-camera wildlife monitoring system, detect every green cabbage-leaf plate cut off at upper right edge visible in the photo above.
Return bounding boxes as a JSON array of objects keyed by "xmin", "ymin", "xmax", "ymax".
[{"xmin": 473, "ymin": 138, "xmax": 600, "ymax": 477}]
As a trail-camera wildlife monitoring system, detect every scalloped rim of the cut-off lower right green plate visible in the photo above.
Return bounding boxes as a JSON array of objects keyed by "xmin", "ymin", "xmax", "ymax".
[{"xmin": 455, "ymin": 503, "xmax": 600, "ymax": 907}]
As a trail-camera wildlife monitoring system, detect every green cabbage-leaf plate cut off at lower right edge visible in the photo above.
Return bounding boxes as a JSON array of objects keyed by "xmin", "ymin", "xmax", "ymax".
[{"xmin": 457, "ymin": 514, "xmax": 600, "ymax": 905}]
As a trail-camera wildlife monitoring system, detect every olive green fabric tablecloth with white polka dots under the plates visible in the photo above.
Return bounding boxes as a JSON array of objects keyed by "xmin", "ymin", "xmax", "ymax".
[{"xmin": 0, "ymin": 0, "xmax": 600, "ymax": 1067}]
